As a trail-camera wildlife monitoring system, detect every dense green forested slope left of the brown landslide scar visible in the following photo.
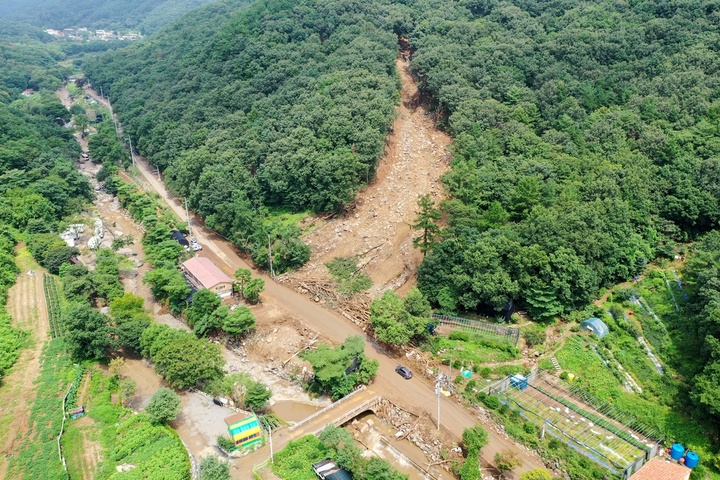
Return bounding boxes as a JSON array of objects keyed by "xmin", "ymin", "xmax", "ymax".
[{"xmin": 86, "ymin": 0, "xmax": 398, "ymax": 271}]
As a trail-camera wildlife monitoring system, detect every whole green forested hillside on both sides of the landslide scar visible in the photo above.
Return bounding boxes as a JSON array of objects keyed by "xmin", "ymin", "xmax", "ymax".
[{"xmin": 87, "ymin": 0, "xmax": 720, "ymax": 308}]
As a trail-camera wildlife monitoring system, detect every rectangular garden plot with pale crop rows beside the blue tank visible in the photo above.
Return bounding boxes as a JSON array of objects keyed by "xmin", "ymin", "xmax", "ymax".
[{"xmin": 500, "ymin": 375, "xmax": 657, "ymax": 474}]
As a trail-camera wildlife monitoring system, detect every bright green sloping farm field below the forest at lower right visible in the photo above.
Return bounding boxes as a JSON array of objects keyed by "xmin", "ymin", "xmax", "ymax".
[{"xmin": 536, "ymin": 266, "xmax": 720, "ymax": 479}]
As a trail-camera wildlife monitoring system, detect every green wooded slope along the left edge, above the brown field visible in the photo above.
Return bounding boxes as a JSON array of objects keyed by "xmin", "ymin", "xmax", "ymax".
[{"xmin": 0, "ymin": 30, "xmax": 92, "ymax": 377}]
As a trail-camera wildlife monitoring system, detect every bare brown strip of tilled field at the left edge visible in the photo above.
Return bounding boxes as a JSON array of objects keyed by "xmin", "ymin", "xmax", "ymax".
[{"xmin": 0, "ymin": 249, "xmax": 50, "ymax": 478}]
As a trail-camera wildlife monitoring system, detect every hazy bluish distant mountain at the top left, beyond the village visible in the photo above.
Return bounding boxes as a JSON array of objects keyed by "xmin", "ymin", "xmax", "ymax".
[{"xmin": 0, "ymin": 0, "xmax": 221, "ymax": 34}]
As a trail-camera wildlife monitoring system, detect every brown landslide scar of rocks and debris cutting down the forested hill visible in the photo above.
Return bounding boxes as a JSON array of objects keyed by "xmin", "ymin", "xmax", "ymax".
[{"xmin": 292, "ymin": 58, "xmax": 451, "ymax": 297}]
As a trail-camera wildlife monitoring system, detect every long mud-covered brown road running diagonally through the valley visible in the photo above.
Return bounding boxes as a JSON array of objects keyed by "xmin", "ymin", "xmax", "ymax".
[{"xmin": 86, "ymin": 89, "xmax": 543, "ymax": 480}]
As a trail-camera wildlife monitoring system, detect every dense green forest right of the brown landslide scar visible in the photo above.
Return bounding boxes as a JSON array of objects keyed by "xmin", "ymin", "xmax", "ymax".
[{"xmin": 410, "ymin": 0, "xmax": 720, "ymax": 319}]
